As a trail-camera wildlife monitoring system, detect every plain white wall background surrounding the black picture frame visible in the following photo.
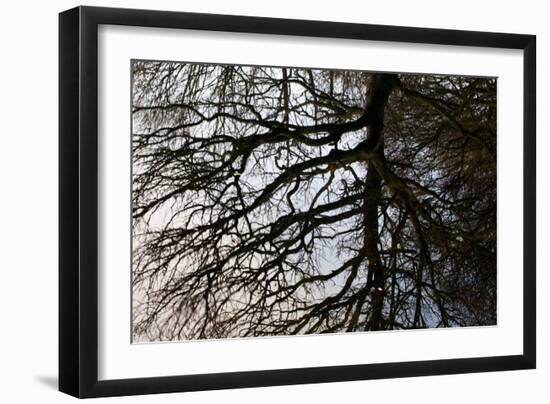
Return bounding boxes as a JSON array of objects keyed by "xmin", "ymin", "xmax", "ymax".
[{"xmin": 0, "ymin": 0, "xmax": 550, "ymax": 404}]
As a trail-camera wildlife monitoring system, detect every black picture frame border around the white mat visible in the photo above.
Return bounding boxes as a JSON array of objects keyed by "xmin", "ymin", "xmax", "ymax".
[{"xmin": 59, "ymin": 7, "xmax": 536, "ymax": 398}]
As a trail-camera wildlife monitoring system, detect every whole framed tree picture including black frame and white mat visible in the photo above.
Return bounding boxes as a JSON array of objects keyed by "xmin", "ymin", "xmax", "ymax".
[{"xmin": 59, "ymin": 7, "xmax": 536, "ymax": 397}]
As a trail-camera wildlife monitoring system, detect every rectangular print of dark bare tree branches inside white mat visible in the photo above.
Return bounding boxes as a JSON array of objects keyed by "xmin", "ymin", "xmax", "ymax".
[{"xmin": 132, "ymin": 62, "xmax": 496, "ymax": 341}]
